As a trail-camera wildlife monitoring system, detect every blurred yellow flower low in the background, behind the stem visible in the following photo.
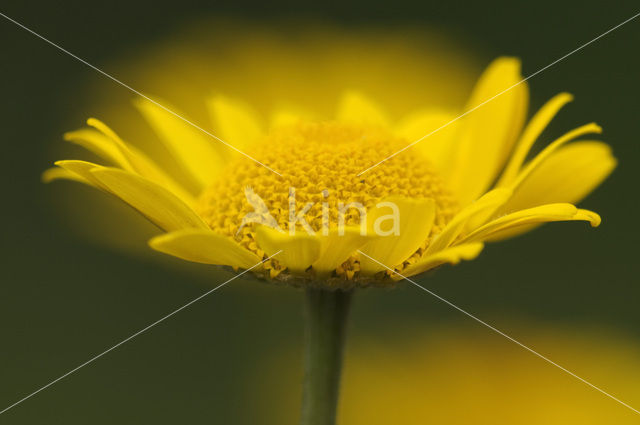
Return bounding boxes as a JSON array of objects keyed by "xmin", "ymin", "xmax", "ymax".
[{"xmin": 256, "ymin": 323, "xmax": 640, "ymax": 425}]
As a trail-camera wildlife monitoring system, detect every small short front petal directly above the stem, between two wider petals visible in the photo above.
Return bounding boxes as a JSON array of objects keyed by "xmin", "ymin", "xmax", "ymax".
[{"xmin": 312, "ymin": 226, "xmax": 372, "ymax": 276}]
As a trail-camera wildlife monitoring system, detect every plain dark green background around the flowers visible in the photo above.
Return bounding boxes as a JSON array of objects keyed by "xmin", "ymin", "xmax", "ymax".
[{"xmin": 0, "ymin": 0, "xmax": 640, "ymax": 424}]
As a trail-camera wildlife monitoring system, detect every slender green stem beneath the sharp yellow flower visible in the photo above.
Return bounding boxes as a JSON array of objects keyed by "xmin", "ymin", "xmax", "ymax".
[{"xmin": 300, "ymin": 289, "xmax": 351, "ymax": 425}]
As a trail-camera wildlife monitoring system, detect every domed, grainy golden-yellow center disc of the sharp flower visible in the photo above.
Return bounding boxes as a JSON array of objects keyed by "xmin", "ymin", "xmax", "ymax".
[{"xmin": 197, "ymin": 122, "xmax": 457, "ymax": 274}]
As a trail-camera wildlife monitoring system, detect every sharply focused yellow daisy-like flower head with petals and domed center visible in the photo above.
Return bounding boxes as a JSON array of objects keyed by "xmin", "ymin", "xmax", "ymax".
[{"xmin": 44, "ymin": 58, "xmax": 616, "ymax": 287}]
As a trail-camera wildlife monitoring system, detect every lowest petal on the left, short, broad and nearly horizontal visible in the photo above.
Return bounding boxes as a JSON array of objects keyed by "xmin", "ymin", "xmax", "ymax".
[{"xmin": 149, "ymin": 229, "xmax": 261, "ymax": 269}]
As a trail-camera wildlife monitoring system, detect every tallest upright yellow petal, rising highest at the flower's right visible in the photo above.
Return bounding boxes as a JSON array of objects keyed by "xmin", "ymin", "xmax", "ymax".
[{"xmin": 449, "ymin": 58, "xmax": 529, "ymax": 205}]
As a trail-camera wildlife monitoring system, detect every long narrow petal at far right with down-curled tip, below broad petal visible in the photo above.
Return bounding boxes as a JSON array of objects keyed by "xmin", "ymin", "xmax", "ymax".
[{"xmin": 461, "ymin": 204, "xmax": 600, "ymax": 243}]
